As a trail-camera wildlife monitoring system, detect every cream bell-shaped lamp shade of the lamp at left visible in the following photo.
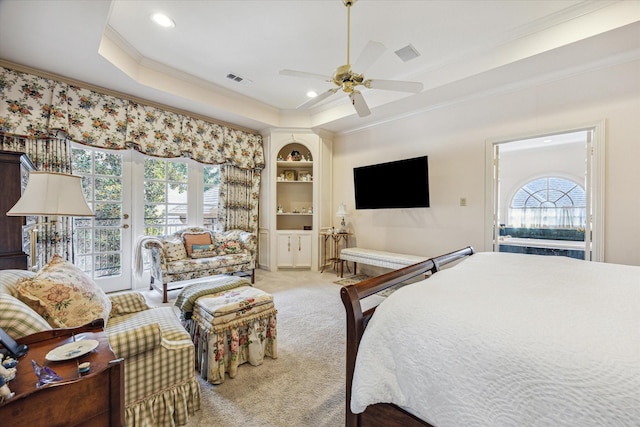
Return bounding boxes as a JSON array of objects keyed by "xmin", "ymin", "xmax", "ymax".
[{"xmin": 7, "ymin": 172, "xmax": 95, "ymax": 216}]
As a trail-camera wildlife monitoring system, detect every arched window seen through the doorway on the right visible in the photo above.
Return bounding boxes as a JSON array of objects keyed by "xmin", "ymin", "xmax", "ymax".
[{"xmin": 508, "ymin": 177, "xmax": 587, "ymax": 228}]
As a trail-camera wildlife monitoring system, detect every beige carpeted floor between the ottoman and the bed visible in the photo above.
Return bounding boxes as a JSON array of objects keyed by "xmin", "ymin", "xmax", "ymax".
[{"xmin": 145, "ymin": 270, "xmax": 374, "ymax": 427}]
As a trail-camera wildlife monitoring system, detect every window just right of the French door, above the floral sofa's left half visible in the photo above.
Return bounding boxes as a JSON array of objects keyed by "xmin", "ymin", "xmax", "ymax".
[{"xmin": 144, "ymin": 158, "xmax": 189, "ymax": 236}]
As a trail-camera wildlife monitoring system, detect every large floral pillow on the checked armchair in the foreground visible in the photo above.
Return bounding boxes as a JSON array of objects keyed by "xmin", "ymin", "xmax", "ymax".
[{"xmin": 18, "ymin": 255, "xmax": 111, "ymax": 328}]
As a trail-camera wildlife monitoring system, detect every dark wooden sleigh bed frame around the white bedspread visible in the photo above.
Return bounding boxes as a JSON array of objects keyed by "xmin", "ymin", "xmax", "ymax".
[{"xmin": 340, "ymin": 246, "xmax": 474, "ymax": 427}]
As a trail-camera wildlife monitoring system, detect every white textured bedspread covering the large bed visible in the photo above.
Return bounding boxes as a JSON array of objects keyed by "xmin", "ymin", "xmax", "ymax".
[{"xmin": 351, "ymin": 253, "xmax": 640, "ymax": 427}]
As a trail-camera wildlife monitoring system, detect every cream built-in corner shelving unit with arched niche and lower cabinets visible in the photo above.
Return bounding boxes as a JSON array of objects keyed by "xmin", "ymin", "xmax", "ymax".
[{"xmin": 258, "ymin": 129, "xmax": 332, "ymax": 270}]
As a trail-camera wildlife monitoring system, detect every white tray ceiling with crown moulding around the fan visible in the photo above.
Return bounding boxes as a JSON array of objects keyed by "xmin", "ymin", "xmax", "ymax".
[{"xmin": 0, "ymin": 0, "xmax": 640, "ymax": 132}]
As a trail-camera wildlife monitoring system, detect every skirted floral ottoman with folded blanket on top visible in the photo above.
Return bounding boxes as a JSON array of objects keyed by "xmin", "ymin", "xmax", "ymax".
[{"xmin": 176, "ymin": 276, "xmax": 278, "ymax": 384}]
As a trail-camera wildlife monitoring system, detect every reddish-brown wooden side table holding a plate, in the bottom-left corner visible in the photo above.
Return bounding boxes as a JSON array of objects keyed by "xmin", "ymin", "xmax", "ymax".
[{"xmin": 0, "ymin": 320, "xmax": 124, "ymax": 427}]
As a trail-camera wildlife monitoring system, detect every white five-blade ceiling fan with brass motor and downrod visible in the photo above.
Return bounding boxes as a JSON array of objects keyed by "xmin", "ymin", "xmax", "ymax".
[{"xmin": 280, "ymin": 0, "xmax": 422, "ymax": 117}]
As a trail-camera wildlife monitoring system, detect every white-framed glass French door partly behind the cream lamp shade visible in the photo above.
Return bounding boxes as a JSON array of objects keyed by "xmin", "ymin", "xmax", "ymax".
[{"xmin": 72, "ymin": 144, "xmax": 133, "ymax": 292}]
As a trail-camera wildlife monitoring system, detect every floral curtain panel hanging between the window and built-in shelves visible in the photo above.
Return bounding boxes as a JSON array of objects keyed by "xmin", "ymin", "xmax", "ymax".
[{"xmin": 218, "ymin": 165, "xmax": 260, "ymax": 232}]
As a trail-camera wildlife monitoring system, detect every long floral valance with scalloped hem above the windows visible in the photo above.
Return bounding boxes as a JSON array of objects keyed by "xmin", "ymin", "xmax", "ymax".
[{"xmin": 0, "ymin": 67, "xmax": 264, "ymax": 169}]
